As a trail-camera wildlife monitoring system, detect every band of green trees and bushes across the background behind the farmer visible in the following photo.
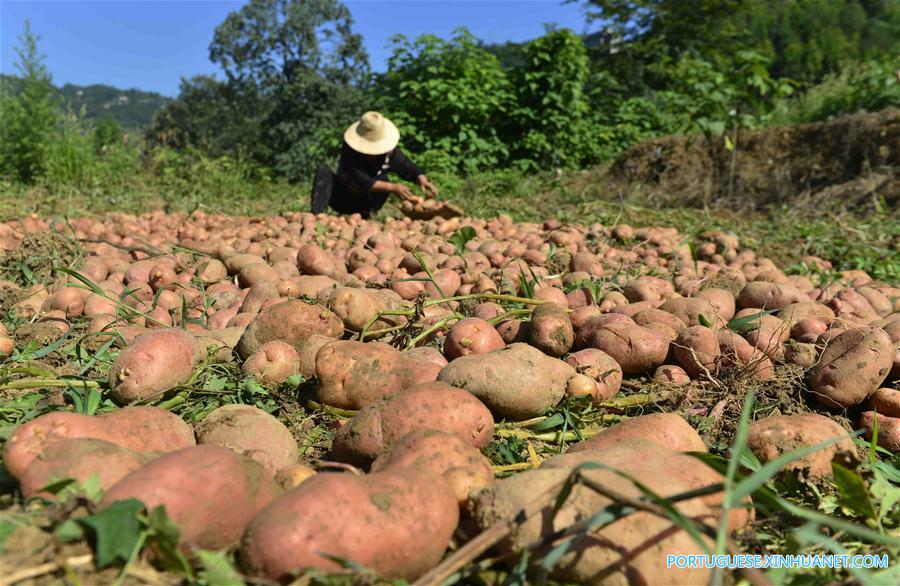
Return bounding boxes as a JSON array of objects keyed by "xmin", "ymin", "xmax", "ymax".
[{"xmin": 0, "ymin": 0, "xmax": 900, "ymax": 198}]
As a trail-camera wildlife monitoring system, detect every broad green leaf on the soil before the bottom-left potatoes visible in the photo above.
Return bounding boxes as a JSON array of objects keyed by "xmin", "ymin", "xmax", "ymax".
[{"xmin": 78, "ymin": 499, "xmax": 145, "ymax": 569}]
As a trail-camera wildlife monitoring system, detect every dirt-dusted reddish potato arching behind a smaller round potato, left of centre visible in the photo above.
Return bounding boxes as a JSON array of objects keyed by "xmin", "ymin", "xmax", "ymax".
[{"xmin": 235, "ymin": 299, "xmax": 344, "ymax": 359}]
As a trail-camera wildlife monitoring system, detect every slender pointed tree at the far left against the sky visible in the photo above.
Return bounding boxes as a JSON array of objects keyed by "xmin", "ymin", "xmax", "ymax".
[{"xmin": 0, "ymin": 20, "xmax": 57, "ymax": 182}]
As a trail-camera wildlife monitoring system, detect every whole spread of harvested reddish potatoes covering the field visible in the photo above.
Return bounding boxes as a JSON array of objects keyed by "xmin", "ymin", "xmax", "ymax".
[{"xmin": 0, "ymin": 211, "xmax": 900, "ymax": 584}]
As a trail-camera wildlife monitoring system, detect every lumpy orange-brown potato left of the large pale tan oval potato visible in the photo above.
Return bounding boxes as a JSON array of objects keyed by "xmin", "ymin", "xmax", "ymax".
[{"xmin": 316, "ymin": 340, "xmax": 414, "ymax": 409}]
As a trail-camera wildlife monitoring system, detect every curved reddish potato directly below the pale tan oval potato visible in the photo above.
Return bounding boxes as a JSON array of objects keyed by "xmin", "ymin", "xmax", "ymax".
[{"xmin": 333, "ymin": 382, "xmax": 494, "ymax": 465}]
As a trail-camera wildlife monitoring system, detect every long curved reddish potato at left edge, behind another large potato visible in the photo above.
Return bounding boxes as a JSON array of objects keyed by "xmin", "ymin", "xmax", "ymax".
[{"xmin": 3, "ymin": 407, "xmax": 195, "ymax": 478}]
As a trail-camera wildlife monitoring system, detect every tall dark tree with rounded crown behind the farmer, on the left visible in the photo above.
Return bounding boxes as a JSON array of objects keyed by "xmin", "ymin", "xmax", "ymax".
[{"xmin": 148, "ymin": 0, "xmax": 369, "ymax": 180}]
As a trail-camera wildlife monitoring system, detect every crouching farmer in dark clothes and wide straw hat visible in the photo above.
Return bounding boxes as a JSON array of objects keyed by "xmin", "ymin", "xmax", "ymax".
[{"xmin": 312, "ymin": 112, "xmax": 438, "ymax": 218}]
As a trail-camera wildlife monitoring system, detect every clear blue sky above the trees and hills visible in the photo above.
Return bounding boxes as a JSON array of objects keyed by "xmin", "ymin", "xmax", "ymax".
[{"xmin": 0, "ymin": 0, "xmax": 586, "ymax": 96}]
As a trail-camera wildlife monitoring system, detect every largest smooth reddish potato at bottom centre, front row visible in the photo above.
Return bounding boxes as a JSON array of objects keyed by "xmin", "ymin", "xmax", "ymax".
[{"xmin": 240, "ymin": 469, "xmax": 459, "ymax": 581}]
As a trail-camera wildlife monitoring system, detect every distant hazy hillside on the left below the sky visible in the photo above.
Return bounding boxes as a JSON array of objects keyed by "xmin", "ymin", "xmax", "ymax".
[{"xmin": 0, "ymin": 74, "xmax": 170, "ymax": 130}]
